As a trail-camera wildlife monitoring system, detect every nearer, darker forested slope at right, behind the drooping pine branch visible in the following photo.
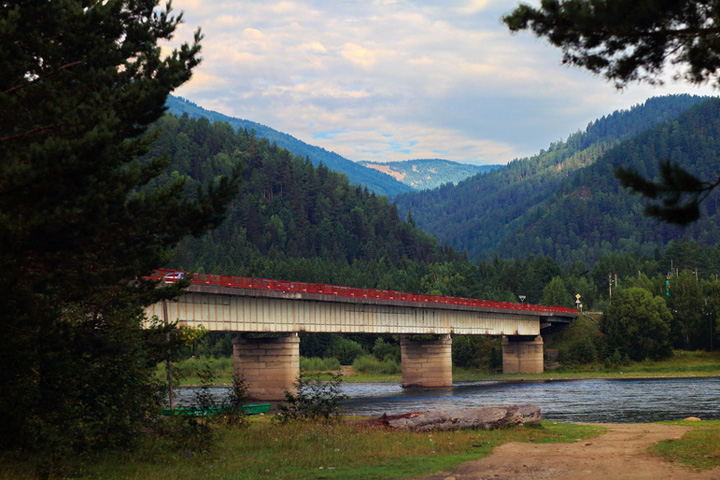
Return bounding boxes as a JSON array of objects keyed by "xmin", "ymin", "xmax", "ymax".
[{"xmin": 502, "ymin": 99, "xmax": 720, "ymax": 261}]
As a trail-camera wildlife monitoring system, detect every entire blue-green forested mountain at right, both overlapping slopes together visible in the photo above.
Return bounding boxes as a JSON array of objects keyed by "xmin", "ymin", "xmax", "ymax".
[{"xmin": 395, "ymin": 95, "xmax": 708, "ymax": 264}]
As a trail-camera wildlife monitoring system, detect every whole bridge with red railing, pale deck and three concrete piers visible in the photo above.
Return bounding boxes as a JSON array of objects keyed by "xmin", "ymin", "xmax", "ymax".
[{"xmin": 146, "ymin": 270, "xmax": 578, "ymax": 400}]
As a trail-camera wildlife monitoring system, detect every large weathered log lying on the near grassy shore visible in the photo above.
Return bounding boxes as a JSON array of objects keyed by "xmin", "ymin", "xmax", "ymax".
[{"xmin": 368, "ymin": 405, "xmax": 542, "ymax": 432}]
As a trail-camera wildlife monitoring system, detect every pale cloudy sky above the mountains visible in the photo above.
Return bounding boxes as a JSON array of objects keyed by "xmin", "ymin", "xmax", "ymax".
[{"xmin": 166, "ymin": 0, "xmax": 717, "ymax": 165}]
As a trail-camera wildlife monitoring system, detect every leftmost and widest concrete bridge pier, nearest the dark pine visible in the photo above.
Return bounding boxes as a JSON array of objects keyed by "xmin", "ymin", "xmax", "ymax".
[{"xmin": 233, "ymin": 333, "xmax": 300, "ymax": 400}]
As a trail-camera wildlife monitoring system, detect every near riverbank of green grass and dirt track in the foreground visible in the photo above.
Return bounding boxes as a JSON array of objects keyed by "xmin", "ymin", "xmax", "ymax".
[{"xmin": 0, "ymin": 417, "xmax": 720, "ymax": 480}]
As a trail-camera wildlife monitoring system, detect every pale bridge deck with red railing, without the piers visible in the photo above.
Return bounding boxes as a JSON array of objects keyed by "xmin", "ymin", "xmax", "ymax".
[{"xmin": 147, "ymin": 271, "xmax": 577, "ymax": 335}]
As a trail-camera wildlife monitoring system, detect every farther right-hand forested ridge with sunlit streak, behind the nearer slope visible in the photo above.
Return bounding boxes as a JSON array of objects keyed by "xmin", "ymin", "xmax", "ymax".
[{"xmin": 395, "ymin": 95, "xmax": 712, "ymax": 261}]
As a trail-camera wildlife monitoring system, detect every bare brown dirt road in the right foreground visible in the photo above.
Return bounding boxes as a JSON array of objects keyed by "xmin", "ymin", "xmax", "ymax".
[{"xmin": 416, "ymin": 424, "xmax": 720, "ymax": 480}]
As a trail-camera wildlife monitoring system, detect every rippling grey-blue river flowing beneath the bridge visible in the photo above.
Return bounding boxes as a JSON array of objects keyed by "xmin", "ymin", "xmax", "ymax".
[{"xmin": 178, "ymin": 377, "xmax": 720, "ymax": 423}]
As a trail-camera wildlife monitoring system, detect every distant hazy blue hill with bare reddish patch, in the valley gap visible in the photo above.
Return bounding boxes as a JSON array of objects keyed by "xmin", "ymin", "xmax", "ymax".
[{"xmin": 358, "ymin": 158, "xmax": 499, "ymax": 190}]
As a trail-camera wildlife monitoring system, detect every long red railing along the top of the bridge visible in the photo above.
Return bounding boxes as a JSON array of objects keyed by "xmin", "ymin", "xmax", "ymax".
[{"xmin": 150, "ymin": 269, "xmax": 578, "ymax": 315}]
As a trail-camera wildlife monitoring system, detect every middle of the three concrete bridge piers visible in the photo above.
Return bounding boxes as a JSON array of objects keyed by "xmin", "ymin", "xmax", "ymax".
[{"xmin": 400, "ymin": 335, "xmax": 452, "ymax": 387}]
